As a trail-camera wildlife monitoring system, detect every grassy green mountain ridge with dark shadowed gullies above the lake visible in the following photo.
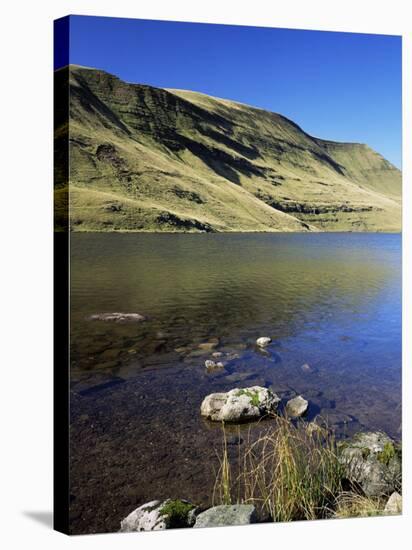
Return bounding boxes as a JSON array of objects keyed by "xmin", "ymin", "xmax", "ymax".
[{"xmin": 55, "ymin": 65, "xmax": 401, "ymax": 231}]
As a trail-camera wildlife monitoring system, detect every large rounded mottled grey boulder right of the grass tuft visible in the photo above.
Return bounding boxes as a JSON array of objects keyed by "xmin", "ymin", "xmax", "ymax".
[{"xmin": 339, "ymin": 432, "xmax": 402, "ymax": 497}]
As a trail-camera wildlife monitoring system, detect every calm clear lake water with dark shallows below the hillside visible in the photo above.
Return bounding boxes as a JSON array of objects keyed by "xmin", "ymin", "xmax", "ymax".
[{"xmin": 70, "ymin": 233, "xmax": 402, "ymax": 533}]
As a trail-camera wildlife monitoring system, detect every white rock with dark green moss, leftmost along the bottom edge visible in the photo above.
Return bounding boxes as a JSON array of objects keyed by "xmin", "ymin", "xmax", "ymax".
[{"xmin": 120, "ymin": 499, "xmax": 196, "ymax": 533}]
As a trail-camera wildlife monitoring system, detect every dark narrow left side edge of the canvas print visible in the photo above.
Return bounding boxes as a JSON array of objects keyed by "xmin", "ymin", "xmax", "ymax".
[{"xmin": 53, "ymin": 17, "xmax": 70, "ymax": 534}]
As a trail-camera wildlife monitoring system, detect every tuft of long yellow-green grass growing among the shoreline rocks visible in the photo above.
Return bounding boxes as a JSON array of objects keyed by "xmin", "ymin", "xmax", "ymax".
[{"xmin": 214, "ymin": 416, "xmax": 344, "ymax": 521}]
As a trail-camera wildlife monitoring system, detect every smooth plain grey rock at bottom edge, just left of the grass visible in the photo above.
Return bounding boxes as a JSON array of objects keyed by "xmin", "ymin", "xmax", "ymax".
[{"xmin": 194, "ymin": 504, "xmax": 256, "ymax": 527}]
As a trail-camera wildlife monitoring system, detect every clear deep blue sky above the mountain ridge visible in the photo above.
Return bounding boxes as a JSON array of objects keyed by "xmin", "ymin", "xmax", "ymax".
[{"xmin": 59, "ymin": 16, "xmax": 402, "ymax": 167}]
